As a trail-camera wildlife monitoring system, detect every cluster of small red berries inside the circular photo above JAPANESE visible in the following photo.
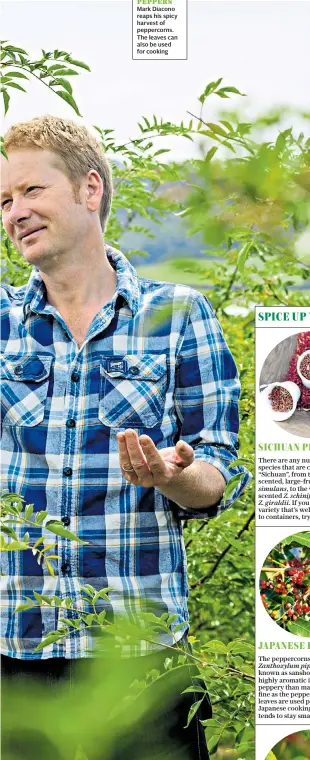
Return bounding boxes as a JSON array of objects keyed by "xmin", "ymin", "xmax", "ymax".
[{"xmin": 260, "ymin": 558, "xmax": 310, "ymax": 628}]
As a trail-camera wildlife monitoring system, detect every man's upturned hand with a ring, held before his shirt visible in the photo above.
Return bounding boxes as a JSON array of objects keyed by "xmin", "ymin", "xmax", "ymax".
[{"xmin": 116, "ymin": 429, "xmax": 195, "ymax": 490}]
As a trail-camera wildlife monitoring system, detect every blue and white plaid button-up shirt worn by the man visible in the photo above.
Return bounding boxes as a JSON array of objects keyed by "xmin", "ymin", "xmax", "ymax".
[{"xmin": 1, "ymin": 246, "xmax": 249, "ymax": 659}]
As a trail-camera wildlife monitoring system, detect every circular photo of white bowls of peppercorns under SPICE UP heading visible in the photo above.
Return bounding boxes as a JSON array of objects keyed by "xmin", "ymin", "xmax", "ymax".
[{"xmin": 259, "ymin": 330, "xmax": 310, "ymax": 438}]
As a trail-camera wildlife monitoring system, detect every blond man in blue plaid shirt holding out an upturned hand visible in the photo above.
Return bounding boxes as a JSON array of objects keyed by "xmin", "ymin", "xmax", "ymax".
[{"xmin": 1, "ymin": 116, "xmax": 249, "ymax": 760}]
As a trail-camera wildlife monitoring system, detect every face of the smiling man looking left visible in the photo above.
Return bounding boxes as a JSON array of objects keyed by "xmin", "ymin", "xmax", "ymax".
[{"xmin": 1, "ymin": 148, "xmax": 89, "ymax": 270}]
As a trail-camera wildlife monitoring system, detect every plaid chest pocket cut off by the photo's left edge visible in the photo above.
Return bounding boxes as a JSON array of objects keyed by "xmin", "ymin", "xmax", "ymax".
[{"xmin": 1, "ymin": 354, "xmax": 52, "ymax": 427}]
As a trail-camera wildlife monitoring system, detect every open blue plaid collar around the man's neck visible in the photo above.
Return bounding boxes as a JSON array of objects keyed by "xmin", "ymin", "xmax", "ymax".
[{"xmin": 23, "ymin": 245, "xmax": 140, "ymax": 321}]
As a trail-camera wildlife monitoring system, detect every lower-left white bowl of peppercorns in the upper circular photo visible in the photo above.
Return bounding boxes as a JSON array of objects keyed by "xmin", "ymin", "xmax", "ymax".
[{"xmin": 261, "ymin": 380, "xmax": 300, "ymax": 422}]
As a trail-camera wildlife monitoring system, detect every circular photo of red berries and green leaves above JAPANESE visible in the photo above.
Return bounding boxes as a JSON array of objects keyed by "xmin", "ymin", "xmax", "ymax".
[{"xmin": 260, "ymin": 531, "xmax": 310, "ymax": 637}]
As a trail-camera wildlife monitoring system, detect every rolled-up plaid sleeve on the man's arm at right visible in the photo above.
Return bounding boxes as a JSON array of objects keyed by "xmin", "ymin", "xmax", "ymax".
[{"xmin": 171, "ymin": 291, "xmax": 251, "ymax": 519}]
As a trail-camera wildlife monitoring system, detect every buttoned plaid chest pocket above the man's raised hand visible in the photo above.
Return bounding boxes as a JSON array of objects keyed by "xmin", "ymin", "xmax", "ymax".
[{"xmin": 99, "ymin": 354, "xmax": 167, "ymax": 427}]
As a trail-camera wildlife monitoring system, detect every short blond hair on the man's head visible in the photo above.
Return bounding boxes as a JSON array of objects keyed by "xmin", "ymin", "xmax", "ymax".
[{"xmin": 4, "ymin": 116, "xmax": 113, "ymax": 231}]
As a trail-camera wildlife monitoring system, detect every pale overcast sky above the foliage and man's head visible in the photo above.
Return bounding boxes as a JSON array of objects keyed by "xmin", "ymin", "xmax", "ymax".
[{"xmin": 1, "ymin": 0, "xmax": 310, "ymax": 158}]
